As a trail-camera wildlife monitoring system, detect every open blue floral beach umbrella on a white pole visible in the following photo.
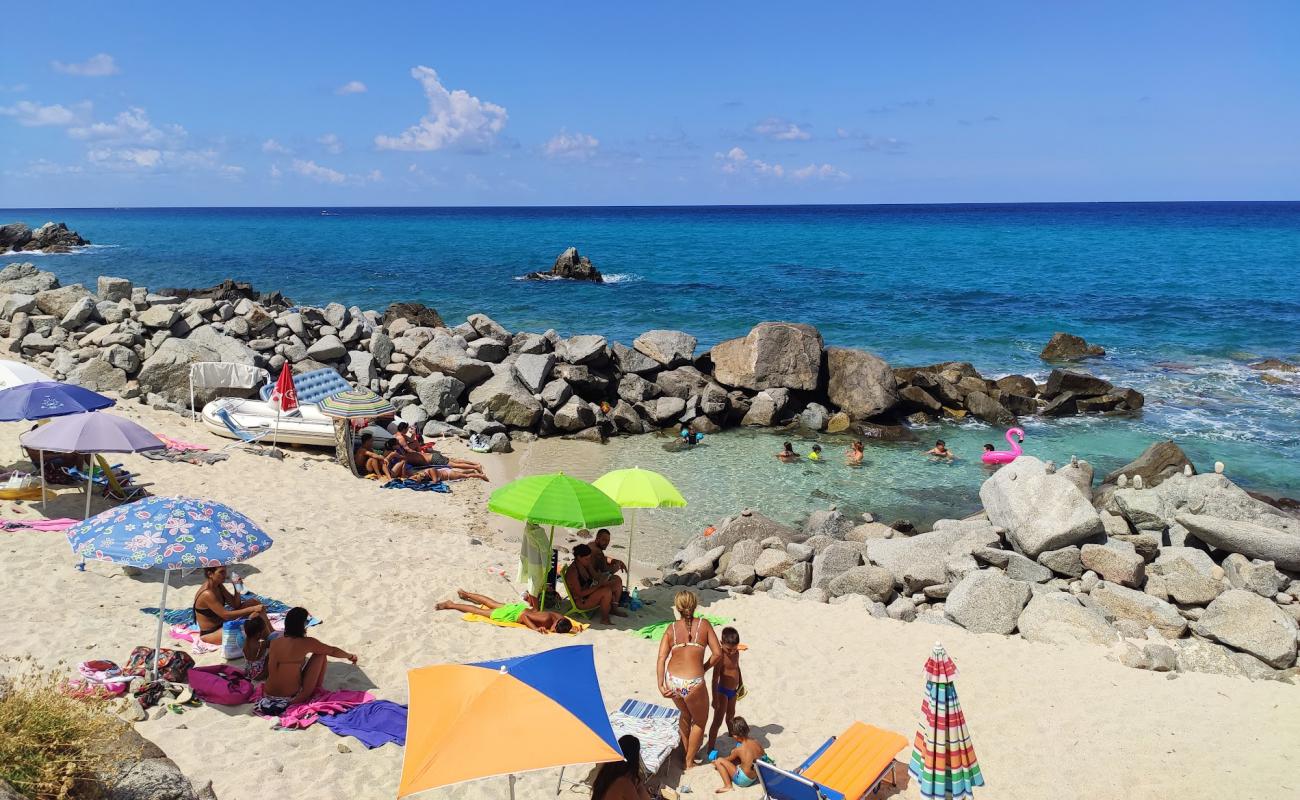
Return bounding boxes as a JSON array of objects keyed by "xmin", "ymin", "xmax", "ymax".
[{"xmin": 68, "ymin": 497, "xmax": 272, "ymax": 674}]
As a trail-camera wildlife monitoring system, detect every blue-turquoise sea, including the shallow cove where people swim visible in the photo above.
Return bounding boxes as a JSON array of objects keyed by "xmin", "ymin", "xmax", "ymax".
[{"xmin": 0, "ymin": 203, "xmax": 1300, "ymax": 559}]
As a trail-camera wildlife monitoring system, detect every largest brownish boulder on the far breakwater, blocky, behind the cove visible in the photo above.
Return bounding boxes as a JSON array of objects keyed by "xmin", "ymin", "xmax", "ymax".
[{"xmin": 709, "ymin": 323, "xmax": 822, "ymax": 392}]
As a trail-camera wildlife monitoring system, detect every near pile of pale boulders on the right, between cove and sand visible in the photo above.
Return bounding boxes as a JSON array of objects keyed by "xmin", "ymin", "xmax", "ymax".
[{"xmin": 664, "ymin": 442, "xmax": 1300, "ymax": 683}]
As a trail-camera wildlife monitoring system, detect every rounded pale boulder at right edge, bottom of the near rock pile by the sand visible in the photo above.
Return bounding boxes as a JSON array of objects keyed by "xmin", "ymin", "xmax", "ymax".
[{"xmin": 1192, "ymin": 589, "xmax": 1296, "ymax": 670}]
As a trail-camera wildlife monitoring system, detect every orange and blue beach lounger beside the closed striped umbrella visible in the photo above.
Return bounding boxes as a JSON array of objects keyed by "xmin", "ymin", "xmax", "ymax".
[{"xmin": 755, "ymin": 722, "xmax": 907, "ymax": 800}]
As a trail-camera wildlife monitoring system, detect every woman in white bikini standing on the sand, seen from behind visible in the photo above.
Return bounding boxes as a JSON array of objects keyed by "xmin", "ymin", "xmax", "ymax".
[{"xmin": 657, "ymin": 592, "xmax": 722, "ymax": 767}]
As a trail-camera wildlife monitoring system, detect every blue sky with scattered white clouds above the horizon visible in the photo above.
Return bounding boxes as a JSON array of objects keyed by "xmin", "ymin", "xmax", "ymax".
[{"xmin": 0, "ymin": 1, "xmax": 1300, "ymax": 207}]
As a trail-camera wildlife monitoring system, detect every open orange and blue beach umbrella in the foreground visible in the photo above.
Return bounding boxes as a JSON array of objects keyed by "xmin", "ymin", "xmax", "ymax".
[{"xmin": 398, "ymin": 645, "xmax": 623, "ymax": 797}]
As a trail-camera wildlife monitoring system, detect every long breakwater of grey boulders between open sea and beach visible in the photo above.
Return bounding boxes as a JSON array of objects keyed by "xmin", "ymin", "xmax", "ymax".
[{"xmin": 0, "ymin": 261, "xmax": 1141, "ymax": 450}]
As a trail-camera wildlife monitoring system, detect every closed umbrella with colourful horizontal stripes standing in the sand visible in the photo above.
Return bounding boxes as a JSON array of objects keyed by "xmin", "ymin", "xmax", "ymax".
[{"xmin": 907, "ymin": 641, "xmax": 984, "ymax": 800}]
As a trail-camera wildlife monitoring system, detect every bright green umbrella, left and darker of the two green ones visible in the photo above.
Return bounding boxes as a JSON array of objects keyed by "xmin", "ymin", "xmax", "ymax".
[{"xmin": 488, "ymin": 472, "xmax": 623, "ymax": 607}]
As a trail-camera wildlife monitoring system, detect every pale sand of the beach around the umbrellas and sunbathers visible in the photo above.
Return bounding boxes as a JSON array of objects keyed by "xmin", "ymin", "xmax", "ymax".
[{"xmin": 0, "ymin": 402, "xmax": 1300, "ymax": 800}]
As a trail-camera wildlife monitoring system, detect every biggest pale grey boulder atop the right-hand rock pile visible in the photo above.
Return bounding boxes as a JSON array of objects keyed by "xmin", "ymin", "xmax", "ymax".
[{"xmin": 979, "ymin": 455, "xmax": 1104, "ymax": 558}]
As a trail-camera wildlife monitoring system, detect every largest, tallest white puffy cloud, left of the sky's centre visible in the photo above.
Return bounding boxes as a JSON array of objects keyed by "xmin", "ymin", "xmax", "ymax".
[{"xmin": 374, "ymin": 66, "xmax": 508, "ymax": 150}]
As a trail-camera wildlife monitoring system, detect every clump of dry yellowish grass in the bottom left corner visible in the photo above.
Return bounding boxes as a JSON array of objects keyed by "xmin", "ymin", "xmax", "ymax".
[{"xmin": 0, "ymin": 662, "xmax": 126, "ymax": 800}]
